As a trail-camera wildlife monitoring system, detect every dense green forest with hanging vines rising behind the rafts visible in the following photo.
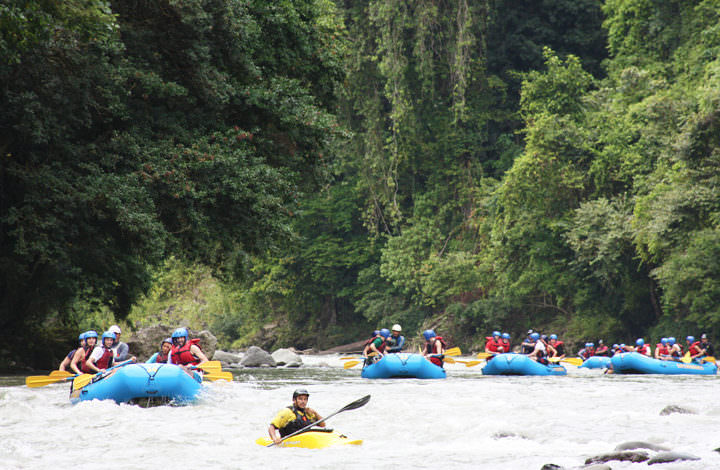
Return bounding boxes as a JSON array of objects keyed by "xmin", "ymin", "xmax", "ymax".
[{"xmin": 0, "ymin": 0, "xmax": 720, "ymax": 364}]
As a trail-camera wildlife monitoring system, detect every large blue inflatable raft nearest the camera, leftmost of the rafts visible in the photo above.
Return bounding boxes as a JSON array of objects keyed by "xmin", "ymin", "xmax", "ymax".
[{"xmin": 70, "ymin": 363, "xmax": 202, "ymax": 405}]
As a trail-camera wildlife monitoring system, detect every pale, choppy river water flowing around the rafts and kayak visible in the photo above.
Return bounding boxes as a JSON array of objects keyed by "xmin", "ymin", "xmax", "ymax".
[{"xmin": 0, "ymin": 355, "xmax": 720, "ymax": 470}]
